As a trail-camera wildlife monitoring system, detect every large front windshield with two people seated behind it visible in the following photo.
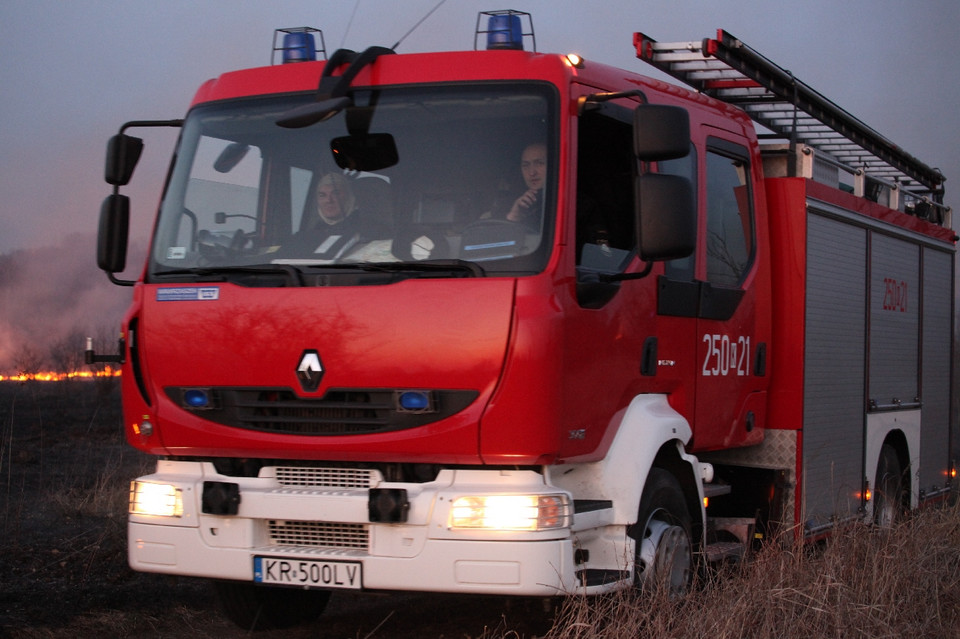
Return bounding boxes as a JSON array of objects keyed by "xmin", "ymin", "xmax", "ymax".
[{"xmin": 150, "ymin": 83, "xmax": 557, "ymax": 283}]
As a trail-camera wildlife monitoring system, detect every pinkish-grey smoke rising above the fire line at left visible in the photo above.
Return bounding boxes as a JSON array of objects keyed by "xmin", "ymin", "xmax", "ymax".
[{"xmin": 0, "ymin": 233, "xmax": 143, "ymax": 374}]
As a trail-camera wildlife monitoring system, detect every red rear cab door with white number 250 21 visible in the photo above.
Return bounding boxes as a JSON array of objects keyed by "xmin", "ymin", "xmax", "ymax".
[{"xmin": 693, "ymin": 129, "xmax": 769, "ymax": 450}]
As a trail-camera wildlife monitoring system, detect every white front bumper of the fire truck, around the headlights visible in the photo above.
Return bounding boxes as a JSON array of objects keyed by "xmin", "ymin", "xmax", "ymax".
[{"xmin": 128, "ymin": 461, "xmax": 578, "ymax": 596}]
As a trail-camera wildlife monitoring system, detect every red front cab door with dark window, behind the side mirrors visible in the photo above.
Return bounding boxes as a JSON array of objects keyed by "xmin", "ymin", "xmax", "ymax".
[{"xmin": 560, "ymin": 92, "xmax": 672, "ymax": 455}]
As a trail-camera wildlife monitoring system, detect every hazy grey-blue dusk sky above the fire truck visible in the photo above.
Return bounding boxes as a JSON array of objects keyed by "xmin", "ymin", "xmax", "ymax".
[{"xmin": 0, "ymin": 0, "xmax": 960, "ymax": 259}]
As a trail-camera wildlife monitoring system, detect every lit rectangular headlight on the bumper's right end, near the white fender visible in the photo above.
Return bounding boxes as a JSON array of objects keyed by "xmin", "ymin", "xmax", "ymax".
[{"xmin": 450, "ymin": 495, "xmax": 570, "ymax": 530}]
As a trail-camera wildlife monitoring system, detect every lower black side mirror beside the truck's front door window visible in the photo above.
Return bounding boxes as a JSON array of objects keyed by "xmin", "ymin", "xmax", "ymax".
[{"xmin": 636, "ymin": 173, "xmax": 697, "ymax": 262}]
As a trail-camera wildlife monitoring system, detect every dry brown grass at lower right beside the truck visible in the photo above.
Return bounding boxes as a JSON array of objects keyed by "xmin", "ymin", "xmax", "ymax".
[{"xmin": 516, "ymin": 507, "xmax": 960, "ymax": 639}]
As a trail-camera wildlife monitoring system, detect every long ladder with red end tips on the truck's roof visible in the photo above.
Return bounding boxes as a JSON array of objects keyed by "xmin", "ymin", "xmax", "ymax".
[{"xmin": 633, "ymin": 29, "xmax": 945, "ymax": 204}]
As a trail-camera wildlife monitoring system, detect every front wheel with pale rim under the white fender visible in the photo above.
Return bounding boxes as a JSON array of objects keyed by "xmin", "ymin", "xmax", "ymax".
[{"xmin": 629, "ymin": 468, "xmax": 694, "ymax": 596}]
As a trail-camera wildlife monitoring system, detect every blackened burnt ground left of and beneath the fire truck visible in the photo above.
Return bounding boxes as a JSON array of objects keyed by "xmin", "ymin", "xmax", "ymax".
[{"xmin": 0, "ymin": 380, "xmax": 549, "ymax": 639}]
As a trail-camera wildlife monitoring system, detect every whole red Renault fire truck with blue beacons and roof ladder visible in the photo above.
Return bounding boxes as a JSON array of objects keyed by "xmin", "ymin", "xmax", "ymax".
[{"xmin": 88, "ymin": 11, "xmax": 957, "ymax": 626}]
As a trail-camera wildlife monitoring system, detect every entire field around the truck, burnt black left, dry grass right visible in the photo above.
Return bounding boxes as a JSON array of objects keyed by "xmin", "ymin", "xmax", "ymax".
[{"xmin": 0, "ymin": 379, "xmax": 960, "ymax": 639}]
